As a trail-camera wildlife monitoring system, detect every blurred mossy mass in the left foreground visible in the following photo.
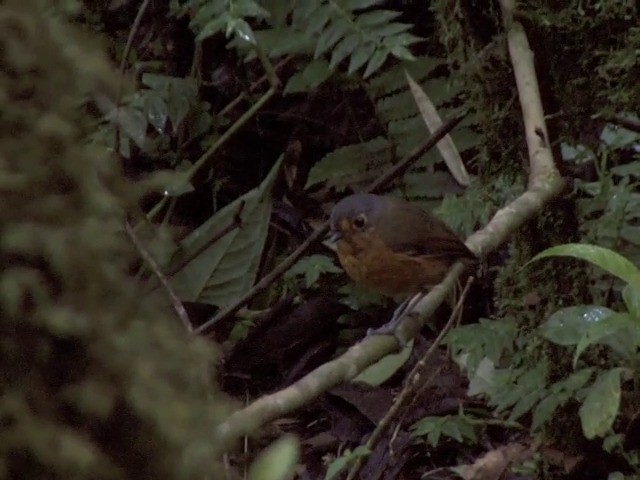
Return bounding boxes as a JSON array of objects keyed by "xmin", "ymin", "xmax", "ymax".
[{"xmin": 0, "ymin": 0, "xmax": 230, "ymax": 480}]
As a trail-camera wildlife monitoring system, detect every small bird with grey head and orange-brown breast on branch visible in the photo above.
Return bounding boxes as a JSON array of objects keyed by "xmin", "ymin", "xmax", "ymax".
[{"xmin": 329, "ymin": 193, "xmax": 477, "ymax": 330}]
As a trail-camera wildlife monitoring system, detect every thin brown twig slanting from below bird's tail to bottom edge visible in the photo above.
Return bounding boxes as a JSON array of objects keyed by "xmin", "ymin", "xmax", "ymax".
[{"xmin": 347, "ymin": 277, "xmax": 473, "ymax": 480}]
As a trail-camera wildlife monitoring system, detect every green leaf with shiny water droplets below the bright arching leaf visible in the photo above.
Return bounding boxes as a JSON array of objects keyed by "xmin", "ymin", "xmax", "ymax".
[{"xmin": 540, "ymin": 305, "xmax": 615, "ymax": 346}]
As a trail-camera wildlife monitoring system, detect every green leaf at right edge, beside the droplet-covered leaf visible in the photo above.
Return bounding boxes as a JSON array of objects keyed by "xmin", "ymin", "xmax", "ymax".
[{"xmin": 573, "ymin": 313, "xmax": 640, "ymax": 368}]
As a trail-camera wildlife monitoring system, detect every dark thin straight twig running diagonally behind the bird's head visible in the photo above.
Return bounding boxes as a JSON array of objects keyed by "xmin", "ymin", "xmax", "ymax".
[{"xmin": 195, "ymin": 116, "xmax": 463, "ymax": 334}]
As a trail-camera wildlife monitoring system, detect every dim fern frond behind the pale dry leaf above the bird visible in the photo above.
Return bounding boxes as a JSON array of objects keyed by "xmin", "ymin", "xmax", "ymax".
[{"xmin": 309, "ymin": 52, "xmax": 479, "ymax": 195}]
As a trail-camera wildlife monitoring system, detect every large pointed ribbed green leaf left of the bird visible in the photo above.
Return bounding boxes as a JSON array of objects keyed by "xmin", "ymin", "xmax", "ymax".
[{"xmin": 168, "ymin": 159, "xmax": 282, "ymax": 306}]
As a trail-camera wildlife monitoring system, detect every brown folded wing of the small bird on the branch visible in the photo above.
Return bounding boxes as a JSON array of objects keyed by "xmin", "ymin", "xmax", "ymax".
[{"xmin": 376, "ymin": 198, "xmax": 476, "ymax": 259}]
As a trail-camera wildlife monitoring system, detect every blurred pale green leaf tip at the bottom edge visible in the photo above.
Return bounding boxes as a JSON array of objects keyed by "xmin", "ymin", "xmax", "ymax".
[{"xmin": 247, "ymin": 436, "xmax": 300, "ymax": 480}]
